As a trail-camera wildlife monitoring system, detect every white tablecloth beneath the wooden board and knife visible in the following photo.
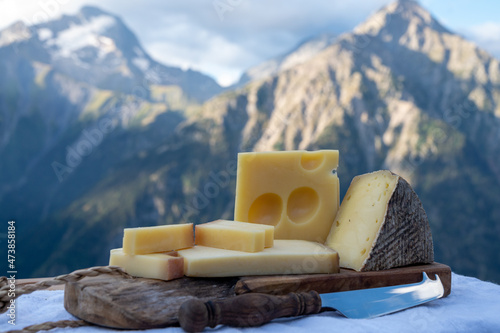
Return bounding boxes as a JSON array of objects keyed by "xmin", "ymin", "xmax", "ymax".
[{"xmin": 0, "ymin": 274, "xmax": 500, "ymax": 333}]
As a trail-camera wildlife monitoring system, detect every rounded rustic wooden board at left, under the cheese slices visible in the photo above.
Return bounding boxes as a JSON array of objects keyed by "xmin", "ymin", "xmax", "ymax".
[{"xmin": 64, "ymin": 275, "xmax": 238, "ymax": 330}]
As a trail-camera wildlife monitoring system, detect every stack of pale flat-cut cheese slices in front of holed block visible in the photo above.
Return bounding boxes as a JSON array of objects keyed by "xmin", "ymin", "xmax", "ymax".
[{"xmin": 110, "ymin": 220, "xmax": 339, "ymax": 280}]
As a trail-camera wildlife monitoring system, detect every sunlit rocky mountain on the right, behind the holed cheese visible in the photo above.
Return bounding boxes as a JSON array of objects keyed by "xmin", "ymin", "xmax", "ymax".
[{"xmin": 194, "ymin": 1, "xmax": 500, "ymax": 280}]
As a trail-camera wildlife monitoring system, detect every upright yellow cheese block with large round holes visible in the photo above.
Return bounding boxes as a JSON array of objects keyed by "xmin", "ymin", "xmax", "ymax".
[{"xmin": 234, "ymin": 150, "xmax": 339, "ymax": 243}]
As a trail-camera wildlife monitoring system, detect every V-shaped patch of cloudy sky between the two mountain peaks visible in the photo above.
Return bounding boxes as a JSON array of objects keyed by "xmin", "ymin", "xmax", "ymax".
[{"xmin": 118, "ymin": 0, "xmax": 388, "ymax": 85}]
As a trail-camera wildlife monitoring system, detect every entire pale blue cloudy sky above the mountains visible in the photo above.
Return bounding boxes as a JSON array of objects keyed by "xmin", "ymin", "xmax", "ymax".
[{"xmin": 0, "ymin": 0, "xmax": 500, "ymax": 86}]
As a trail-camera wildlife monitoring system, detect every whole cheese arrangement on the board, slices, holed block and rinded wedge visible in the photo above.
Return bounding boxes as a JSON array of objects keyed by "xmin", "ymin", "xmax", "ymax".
[{"xmin": 110, "ymin": 150, "xmax": 434, "ymax": 280}]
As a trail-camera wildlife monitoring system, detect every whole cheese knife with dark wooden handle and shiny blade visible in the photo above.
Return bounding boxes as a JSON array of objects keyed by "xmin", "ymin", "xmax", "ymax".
[{"xmin": 178, "ymin": 272, "xmax": 444, "ymax": 332}]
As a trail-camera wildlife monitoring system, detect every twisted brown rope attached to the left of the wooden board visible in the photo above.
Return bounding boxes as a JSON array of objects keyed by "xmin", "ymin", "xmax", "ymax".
[{"xmin": 0, "ymin": 266, "xmax": 132, "ymax": 333}]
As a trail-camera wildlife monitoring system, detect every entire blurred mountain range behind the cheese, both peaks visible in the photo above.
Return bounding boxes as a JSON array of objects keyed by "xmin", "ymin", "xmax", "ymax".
[{"xmin": 0, "ymin": 1, "xmax": 500, "ymax": 282}]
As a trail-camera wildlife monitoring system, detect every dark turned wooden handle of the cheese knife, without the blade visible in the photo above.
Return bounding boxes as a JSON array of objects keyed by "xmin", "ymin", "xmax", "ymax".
[{"xmin": 178, "ymin": 291, "xmax": 321, "ymax": 332}]
